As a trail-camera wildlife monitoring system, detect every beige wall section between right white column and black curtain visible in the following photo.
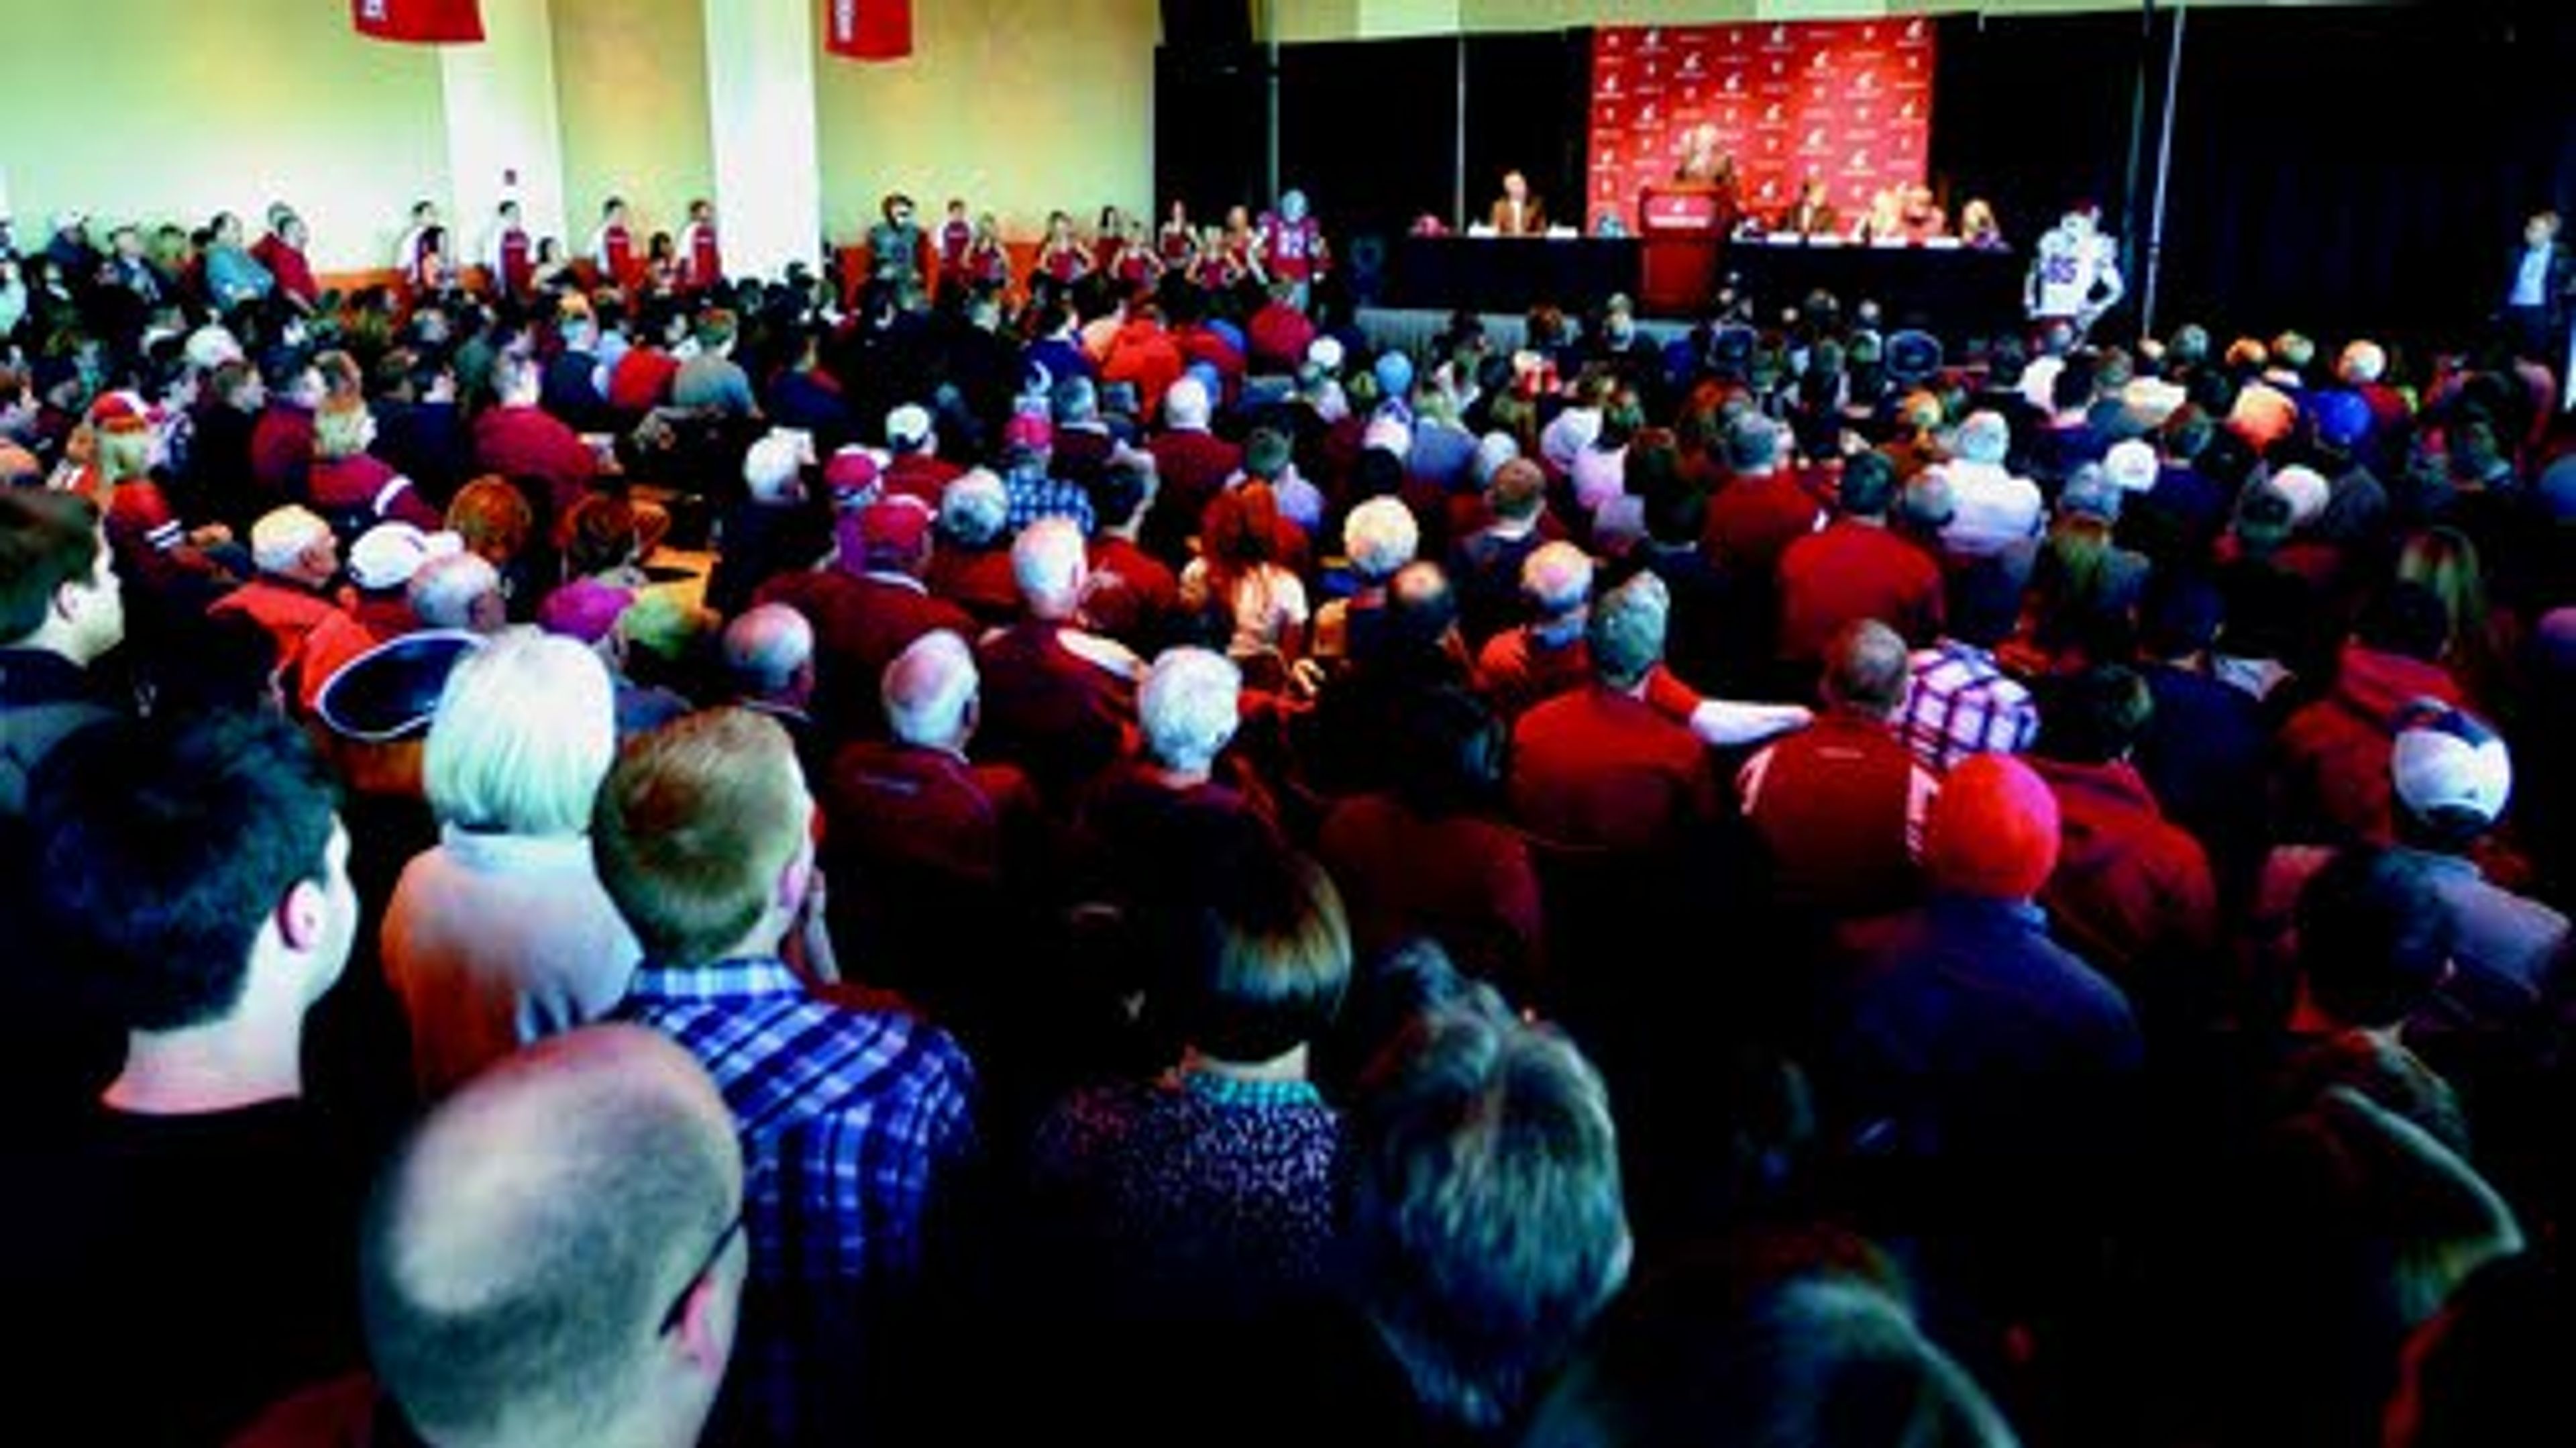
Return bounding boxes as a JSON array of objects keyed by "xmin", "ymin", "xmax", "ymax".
[{"xmin": 814, "ymin": 0, "xmax": 1162, "ymax": 245}]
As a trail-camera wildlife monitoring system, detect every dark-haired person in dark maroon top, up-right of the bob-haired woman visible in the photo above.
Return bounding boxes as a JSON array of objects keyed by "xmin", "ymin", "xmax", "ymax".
[{"xmin": 1316, "ymin": 688, "xmax": 1543, "ymax": 1000}]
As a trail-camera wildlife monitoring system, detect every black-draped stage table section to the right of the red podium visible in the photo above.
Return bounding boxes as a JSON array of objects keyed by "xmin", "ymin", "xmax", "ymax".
[{"xmin": 1718, "ymin": 237, "xmax": 2025, "ymax": 338}]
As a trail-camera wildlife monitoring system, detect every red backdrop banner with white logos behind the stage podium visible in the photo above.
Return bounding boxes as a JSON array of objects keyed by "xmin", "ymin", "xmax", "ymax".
[{"xmin": 1585, "ymin": 15, "xmax": 1932, "ymax": 229}]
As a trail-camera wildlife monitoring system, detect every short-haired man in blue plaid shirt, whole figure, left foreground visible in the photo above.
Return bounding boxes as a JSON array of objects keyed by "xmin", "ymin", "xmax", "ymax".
[{"xmin": 590, "ymin": 709, "xmax": 974, "ymax": 1443}]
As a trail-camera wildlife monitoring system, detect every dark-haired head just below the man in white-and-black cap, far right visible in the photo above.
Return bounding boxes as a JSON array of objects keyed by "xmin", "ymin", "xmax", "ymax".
[{"xmin": 2298, "ymin": 845, "xmax": 2453, "ymax": 1031}]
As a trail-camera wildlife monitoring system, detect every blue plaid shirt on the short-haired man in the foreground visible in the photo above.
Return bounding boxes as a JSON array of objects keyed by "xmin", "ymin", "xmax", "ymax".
[{"xmin": 619, "ymin": 958, "xmax": 974, "ymax": 1443}]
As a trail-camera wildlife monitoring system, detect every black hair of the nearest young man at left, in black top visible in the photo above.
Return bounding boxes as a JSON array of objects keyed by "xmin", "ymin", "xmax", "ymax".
[{"xmin": 28, "ymin": 714, "xmax": 337, "ymax": 1031}]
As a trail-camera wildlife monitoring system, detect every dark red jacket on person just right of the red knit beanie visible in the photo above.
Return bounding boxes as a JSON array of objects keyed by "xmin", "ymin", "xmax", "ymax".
[{"xmin": 2030, "ymin": 755, "xmax": 2218, "ymax": 979}]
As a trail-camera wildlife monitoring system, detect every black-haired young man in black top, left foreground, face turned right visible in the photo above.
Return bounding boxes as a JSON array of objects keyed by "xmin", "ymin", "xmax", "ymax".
[{"xmin": 10, "ymin": 714, "xmax": 368, "ymax": 1443}]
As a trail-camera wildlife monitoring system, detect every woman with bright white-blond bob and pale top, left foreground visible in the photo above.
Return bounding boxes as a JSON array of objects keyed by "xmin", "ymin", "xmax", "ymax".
[{"xmin": 384, "ymin": 629, "xmax": 639, "ymax": 1098}]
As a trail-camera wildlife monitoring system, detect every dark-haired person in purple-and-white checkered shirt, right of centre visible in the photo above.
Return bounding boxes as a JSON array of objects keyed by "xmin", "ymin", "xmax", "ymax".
[{"xmin": 1896, "ymin": 556, "xmax": 2040, "ymax": 773}]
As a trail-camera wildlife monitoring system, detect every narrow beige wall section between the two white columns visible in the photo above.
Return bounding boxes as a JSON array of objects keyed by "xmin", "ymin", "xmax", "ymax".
[{"xmin": 554, "ymin": 0, "xmax": 716, "ymax": 250}]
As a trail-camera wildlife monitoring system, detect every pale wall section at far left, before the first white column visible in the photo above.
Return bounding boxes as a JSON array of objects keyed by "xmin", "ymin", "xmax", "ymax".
[{"xmin": 0, "ymin": 0, "xmax": 451, "ymax": 270}]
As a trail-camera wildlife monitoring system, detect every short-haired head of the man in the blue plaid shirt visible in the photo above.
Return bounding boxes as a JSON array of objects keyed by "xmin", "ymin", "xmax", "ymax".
[{"xmin": 590, "ymin": 709, "xmax": 812, "ymax": 966}]
